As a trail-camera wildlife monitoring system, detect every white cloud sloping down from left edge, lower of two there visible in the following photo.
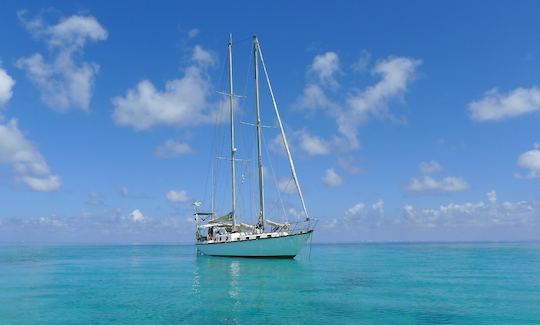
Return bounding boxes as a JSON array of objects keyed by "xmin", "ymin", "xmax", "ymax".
[{"xmin": 0, "ymin": 119, "xmax": 61, "ymax": 192}]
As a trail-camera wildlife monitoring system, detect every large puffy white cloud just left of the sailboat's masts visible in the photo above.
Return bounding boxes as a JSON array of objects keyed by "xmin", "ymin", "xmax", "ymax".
[{"xmin": 112, "ymin": 46, "xmax": 216, "ymax": 130}]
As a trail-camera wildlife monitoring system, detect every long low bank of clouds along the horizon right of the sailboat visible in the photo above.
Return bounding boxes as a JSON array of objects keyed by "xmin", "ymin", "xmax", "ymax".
[{"xmin": 323, "ymin": 190, "xmax": 540, "ymax": 235}]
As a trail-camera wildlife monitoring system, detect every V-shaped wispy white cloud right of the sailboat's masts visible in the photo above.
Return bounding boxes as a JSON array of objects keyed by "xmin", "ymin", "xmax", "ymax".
[{"xmin": 295, "ymin": 52, "xmax": 422, "ymax": 150}]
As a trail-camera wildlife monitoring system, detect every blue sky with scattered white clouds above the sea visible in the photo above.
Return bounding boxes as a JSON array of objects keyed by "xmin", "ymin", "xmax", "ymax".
[{"xmin": 0, "ymin": 1, "xmax": 540, "ymax": 243}]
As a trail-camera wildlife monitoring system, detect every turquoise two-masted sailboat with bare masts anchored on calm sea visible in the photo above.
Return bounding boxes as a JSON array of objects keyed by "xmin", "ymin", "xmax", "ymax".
[{"xmin": 194, "ymin": 36, "xmax": 317, "ymax": 258}]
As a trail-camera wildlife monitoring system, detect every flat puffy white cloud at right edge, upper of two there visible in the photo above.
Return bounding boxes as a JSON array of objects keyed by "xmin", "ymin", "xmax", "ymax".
[{"xmin": 468, "ymin": 87, "xmax": 540, "ymax": 122}]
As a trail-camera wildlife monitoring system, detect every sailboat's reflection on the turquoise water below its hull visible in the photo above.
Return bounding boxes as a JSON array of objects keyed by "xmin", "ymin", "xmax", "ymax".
[{"xmin": 192, "ymin": 256, "xmax": 309, "ymax": 322}]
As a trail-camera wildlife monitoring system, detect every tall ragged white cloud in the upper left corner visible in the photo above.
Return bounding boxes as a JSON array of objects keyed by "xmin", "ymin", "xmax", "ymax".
[{"xmin": 16, "ymin": 11, "xmax": 108, "ymax": 111}]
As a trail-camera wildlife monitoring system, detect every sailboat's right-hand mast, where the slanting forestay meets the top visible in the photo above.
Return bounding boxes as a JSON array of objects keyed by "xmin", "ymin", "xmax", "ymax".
[{"xmin": 253, "ymin": 36, "xmax": 265, "ymax": 229}]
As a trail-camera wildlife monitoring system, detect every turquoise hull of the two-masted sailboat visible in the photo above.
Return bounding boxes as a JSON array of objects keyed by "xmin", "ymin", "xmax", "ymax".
[{"xmin": 196, "ymin": 231, "xmax": 311, "ymax": 258}]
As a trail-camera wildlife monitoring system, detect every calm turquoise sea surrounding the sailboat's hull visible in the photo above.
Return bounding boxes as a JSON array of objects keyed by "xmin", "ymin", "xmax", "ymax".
[{"xmin": 0, "ymin": 243, "xmax": 540, "ymax": 324}]
